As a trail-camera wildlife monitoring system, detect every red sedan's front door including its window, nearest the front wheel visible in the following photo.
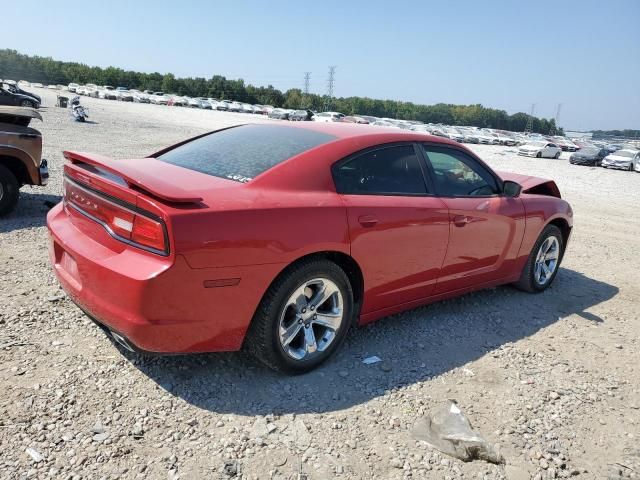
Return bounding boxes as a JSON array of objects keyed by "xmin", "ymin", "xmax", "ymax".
[{"xmin": 423, "ymin": 145, "xmax": 525, "ymax": 294}]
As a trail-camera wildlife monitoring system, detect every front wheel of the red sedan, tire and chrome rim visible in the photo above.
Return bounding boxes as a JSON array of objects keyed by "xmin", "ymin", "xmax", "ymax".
[{"xmin": 515, "ymin": 225, "xmax": 564, "ymax": 293}]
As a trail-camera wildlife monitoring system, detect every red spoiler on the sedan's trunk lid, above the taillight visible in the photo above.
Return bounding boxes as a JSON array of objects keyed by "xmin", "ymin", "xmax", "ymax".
[{"xmin": 63, "ymin": 151, "xmax": 202, "ymax": 203}]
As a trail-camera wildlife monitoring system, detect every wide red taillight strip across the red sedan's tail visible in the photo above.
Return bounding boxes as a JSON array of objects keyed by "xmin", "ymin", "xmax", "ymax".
[{"xmin": 64, "ymin": 177, "xmax": 169, "ymax": 255}]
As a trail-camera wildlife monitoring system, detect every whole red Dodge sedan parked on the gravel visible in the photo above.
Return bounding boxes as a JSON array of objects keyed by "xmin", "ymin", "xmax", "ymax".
[{"xmin": 47, "ymin": 122, "xmax": 573, "ymax": 372}]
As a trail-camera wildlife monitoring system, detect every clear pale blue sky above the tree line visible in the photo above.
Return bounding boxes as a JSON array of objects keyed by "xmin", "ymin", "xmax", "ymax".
[{"xmin": 0, "ymin": 0, "xmax": 640, "ymax": 130}]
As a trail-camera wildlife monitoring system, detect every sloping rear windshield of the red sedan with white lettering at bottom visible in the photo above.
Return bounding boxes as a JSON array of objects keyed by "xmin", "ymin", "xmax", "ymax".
[{"xmin": 158, "ymin": 125, "xmax": 336, "ymax": 183}]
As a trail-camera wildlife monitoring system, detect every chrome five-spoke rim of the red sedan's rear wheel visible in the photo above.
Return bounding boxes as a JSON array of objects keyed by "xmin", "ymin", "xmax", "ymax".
[{"xmin": 278, "ymin": 278, "xmax": 344, "ymax": 361}]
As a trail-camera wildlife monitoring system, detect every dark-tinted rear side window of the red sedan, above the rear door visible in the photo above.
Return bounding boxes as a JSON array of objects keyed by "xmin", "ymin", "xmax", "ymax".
[{"xmin": 333, "ymin": 145, "xmax": 428, "ymax": 195}]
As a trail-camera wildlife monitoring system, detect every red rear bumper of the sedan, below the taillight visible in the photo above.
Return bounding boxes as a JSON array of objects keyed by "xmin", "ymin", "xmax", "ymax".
[{"xmin": 47, "ymin": 204, "xmax": 282, "ymax": 354}]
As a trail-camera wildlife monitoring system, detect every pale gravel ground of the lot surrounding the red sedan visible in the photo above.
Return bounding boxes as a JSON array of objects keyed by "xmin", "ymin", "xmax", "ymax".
[{"xmin": 0, "ymin": 90, "xmax": 640, "ymax": 480}]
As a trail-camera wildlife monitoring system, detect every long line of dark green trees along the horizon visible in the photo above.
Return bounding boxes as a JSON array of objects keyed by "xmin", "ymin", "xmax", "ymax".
[{"xmin": 0, "ymin": 49, "xmax": 562, "ymax": 134}]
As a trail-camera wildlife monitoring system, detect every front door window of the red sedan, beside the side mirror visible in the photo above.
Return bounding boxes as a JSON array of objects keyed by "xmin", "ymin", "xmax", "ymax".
[{"xmin": 423, "ymin": 145, "xmax": 500, "ymax": 197}]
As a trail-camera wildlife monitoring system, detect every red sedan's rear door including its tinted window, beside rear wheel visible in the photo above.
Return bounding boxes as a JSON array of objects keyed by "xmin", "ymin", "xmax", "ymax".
[{"xmin": 333, "ymin": 143, "xmax": 449, "ymax": 313}]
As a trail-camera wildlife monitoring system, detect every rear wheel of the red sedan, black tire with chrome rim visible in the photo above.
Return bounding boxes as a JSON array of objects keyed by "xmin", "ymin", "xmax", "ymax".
[{"xmin": 245, "ymin": 259, "xmax": 354, "ymax": 374}]
